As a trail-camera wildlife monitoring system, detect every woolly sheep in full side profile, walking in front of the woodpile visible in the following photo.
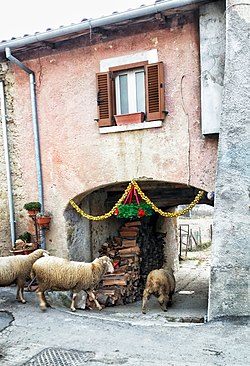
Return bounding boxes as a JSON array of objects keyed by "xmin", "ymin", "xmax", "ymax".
[{"xmin": 32, "ymin": 256, "xmax": 114, "ymax": 311}]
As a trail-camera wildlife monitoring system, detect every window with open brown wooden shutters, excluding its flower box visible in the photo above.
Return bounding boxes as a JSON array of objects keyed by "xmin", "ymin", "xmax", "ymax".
[{"xmin": 97, "ymin": 61, "xmax": 166, "ymax": 127}]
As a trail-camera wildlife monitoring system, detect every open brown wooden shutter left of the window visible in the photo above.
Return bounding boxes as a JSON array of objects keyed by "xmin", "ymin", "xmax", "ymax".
[{"xmin": 96, "ymin": 72, "xmax": 113, "ymax": 127}]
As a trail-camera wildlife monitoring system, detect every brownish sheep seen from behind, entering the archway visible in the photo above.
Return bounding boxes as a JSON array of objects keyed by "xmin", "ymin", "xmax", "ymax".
[{"xmin": 142, "ymin": 268, "xmax": 175, "ymax": 314}]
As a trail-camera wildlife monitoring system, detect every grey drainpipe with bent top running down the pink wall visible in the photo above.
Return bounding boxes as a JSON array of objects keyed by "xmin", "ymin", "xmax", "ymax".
[{"xmin": 5, "ymin": 48, "xmax": 45, "ymax": 249}]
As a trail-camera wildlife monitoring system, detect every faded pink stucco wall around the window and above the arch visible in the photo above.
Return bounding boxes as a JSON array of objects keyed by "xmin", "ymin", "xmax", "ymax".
[{"xmin": 9, "ymin": 17, "xmax": 217, "ymax": 254}]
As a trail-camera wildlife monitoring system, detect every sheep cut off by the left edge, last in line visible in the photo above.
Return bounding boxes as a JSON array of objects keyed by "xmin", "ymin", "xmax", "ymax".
[{"xmin": 0, "ymin": 249, "xmax": 49, "ymax": 304}]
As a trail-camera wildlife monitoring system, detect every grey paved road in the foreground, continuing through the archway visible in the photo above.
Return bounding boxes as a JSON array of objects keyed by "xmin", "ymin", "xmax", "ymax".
[{"xmin": 0, "ymin": 247, "xmax": 250, "ymax": 366}]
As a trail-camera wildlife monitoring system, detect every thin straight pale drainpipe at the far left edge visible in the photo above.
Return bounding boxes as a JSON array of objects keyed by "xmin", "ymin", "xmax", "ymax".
[{"xmin": 0, "ymin": 81, "xmax": 16, "ymax": 248}]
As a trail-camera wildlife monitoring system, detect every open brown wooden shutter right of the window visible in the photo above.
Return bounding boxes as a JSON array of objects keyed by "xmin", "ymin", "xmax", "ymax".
[{"xmin": 145, "ymin": 62, "xmax": 166, "ymax": 121}]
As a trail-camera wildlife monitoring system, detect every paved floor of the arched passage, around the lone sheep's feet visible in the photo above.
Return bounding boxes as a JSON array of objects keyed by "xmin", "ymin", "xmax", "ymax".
[{"xmin": 94, "ymin": 250, "xmax": 210, "ymax": 324}]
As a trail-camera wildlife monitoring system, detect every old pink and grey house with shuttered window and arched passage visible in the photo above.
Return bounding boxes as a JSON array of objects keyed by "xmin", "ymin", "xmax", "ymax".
[{"xmin": 0, "ymin": 0, "xmax": 250, "ymax": 319}]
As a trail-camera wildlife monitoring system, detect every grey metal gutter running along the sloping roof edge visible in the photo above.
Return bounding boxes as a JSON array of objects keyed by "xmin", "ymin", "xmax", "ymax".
[{"xmin": 0, "ymin": 0, "xmax": 208, "ymax": 52}]
